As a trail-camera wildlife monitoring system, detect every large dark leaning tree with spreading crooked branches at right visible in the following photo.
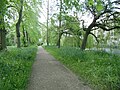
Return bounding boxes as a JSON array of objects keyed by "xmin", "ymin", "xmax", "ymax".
[{"xmin": 81, "ymin": 0, "xmax": 120, "ymax": 50}]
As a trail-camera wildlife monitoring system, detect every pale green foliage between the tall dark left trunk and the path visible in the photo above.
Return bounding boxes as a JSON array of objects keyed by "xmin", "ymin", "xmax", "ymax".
[{"xmin": 22, "ymin": 0, "xmax": 40, "ymax": 44}]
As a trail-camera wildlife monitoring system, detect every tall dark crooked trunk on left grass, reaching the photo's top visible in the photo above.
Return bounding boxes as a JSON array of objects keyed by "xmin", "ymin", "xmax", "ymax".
[{"xmin": 16, "ymin": 0, "xmax": 23, "ymax": 48}]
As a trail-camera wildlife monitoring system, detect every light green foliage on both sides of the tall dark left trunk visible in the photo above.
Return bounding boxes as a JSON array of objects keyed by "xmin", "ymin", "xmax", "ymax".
[{"xmin": 3, "ymin": 0, "xmax": 40, "ymax": 45}]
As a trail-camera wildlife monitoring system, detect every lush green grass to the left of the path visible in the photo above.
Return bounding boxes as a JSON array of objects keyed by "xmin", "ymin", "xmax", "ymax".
[{"xmin": 0, "ymin": 46, "xmax": 37, "ymax": 90}]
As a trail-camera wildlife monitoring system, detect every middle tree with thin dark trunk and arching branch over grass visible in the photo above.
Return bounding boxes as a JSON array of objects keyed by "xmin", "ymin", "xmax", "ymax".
[{"xmin": 57, "ymin": 0, "xmax": 81, "ymax": 48}]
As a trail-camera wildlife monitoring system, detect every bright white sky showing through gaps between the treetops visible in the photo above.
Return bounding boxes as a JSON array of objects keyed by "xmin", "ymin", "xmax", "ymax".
[{"xmin": 39, "ymin": 0, "xmax": 92, "ymax": 26}]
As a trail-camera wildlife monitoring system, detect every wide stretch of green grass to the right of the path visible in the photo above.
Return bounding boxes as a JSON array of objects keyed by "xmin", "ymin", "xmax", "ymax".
[{"xmin": 45, "ymin": 46, "xmax": 120, "ymax": 90}]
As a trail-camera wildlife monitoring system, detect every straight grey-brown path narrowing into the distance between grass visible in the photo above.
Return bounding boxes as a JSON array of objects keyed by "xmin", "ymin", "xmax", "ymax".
[{"xmin": 28, "ymin": 47, "xmax": 91, "ymax": 90}]
